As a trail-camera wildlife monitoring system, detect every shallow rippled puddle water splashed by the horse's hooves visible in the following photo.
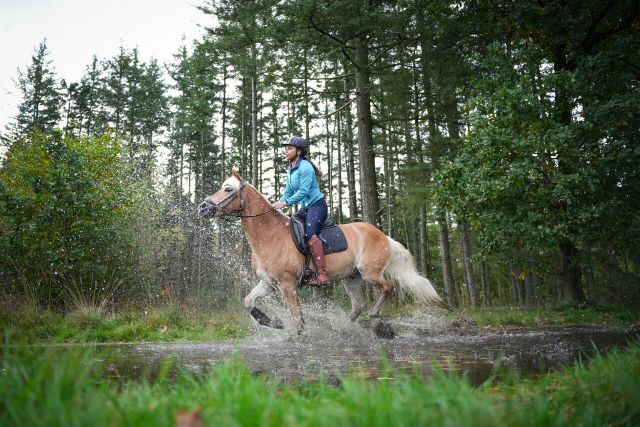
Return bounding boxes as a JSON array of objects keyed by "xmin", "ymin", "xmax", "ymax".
[{"xmin": 106, "ymin": 310, "xmax": 638, "ymax": 385}]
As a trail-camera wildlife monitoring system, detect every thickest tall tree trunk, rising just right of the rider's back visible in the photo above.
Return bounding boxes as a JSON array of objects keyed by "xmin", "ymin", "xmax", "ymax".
[{"xmin": 354, "ymin": 37, "xmax": 379, "ymax": 225}]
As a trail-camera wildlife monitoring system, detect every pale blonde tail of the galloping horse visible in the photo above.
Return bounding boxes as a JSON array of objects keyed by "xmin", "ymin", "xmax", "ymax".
[{"xmin": 384, "ymin": 236, "xmax": 442, "ymax": 304}]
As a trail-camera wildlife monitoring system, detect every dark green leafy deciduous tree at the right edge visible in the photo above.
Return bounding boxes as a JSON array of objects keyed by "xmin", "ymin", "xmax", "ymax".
[{"xmin": 436, "ymin": 2, "xmax": 640, "ymax": 282}]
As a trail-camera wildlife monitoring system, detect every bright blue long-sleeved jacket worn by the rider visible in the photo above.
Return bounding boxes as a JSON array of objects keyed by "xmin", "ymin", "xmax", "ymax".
[{"xmin": 279, "ymin": 158, "xmax": 324, "ymax": 208}]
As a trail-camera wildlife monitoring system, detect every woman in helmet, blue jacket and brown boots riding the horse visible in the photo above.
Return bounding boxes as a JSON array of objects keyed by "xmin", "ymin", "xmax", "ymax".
[{"xmin": 273, "ymin": 136, "xmax": 329, "ymax": 286}]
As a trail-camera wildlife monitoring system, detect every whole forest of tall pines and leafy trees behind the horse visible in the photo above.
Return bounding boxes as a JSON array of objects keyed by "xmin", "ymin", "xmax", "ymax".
[{"xmin": 0, "ymin": 0, "xmax": 640, "ymax": 310}]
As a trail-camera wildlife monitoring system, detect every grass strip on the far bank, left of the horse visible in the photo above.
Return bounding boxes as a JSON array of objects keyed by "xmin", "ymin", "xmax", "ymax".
[{"xmin": 0, "ymin": 306, "xmax": 251, "ymax": 344}]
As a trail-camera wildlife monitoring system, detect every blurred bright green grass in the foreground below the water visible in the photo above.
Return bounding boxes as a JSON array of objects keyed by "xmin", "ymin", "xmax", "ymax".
[{"xmin": 0, "ymin": 345, "xmax": 640, "ymax": 427}]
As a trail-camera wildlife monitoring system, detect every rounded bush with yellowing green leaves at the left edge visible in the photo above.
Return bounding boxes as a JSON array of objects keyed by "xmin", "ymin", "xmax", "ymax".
[{"xmin": 0, "ymin": 133, "xmax": 137, "ymax": 305}]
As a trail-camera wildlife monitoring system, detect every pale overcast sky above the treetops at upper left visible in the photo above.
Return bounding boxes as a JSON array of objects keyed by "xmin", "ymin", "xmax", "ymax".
[{"xmin": 0, "ymin": 0, "xmax": 211, "ymax": 129}]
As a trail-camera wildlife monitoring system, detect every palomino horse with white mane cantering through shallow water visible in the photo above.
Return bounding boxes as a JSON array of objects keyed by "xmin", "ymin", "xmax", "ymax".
[{"xmin": 199, "ymin": 172, "xmax": 442, "ymax": 333}]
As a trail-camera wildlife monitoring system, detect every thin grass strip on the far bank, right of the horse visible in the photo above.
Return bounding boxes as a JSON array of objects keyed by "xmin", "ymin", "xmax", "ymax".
[{"xmin": 462, "ymin": 306, "xmax": 640, "ymax": 327}]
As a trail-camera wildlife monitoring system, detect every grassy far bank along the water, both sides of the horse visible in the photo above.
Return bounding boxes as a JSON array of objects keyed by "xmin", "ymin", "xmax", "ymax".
[{"xmin": 0, "ymin": 306, "xmax": 640, "ymax": 344}]
